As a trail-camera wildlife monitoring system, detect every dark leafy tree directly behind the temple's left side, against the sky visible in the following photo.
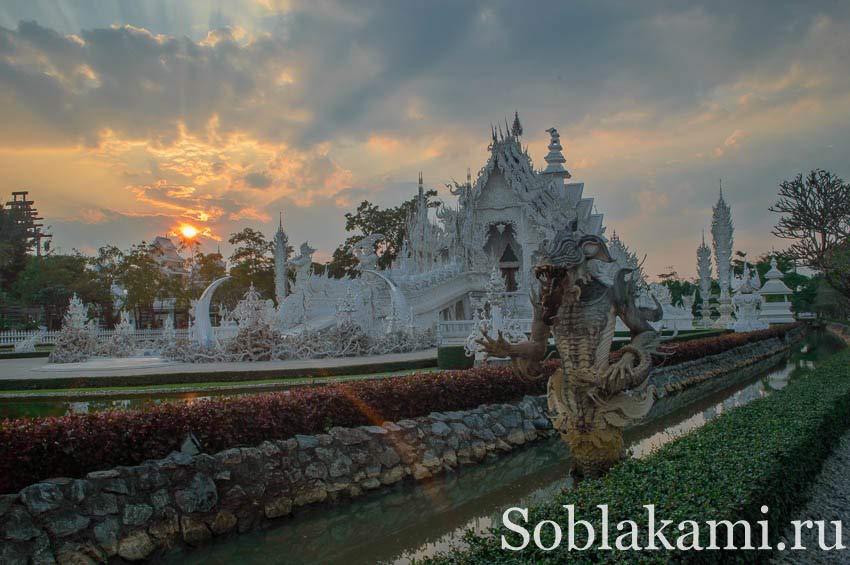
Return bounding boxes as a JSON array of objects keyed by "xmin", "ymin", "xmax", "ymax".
[{"xmin": 328, "ymin": 189, "xmax": 440, "ymax": 278}]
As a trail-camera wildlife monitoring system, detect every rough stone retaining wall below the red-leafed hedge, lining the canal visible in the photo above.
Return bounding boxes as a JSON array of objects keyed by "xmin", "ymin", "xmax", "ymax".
[{"xmin": 0, "ymin": 328, "xmax": 794, "ymax": 564}]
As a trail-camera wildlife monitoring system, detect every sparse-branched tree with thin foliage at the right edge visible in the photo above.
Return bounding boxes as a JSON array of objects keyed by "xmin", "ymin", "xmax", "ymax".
[{"xmin": 770, "ymin": 169, "xmax": 850, "ymax": 298}]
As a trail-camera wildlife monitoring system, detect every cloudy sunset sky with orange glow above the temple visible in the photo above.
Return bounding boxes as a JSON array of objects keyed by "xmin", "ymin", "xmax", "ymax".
[{"xmin": 0, "ymin": 0, "xmax": 850, "ymax": 276}]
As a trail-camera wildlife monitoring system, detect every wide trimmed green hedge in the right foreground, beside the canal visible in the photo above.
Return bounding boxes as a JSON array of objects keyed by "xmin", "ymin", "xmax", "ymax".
[{"xmin": 433, "ymin": 350, "xmax": 850, "ymax": 563}]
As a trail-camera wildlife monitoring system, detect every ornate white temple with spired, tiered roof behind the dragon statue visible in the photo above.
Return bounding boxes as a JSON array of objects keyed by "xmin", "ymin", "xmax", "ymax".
[{"xmin": 192, "ymin": 115, "xmax": 693, "ymax": 344}]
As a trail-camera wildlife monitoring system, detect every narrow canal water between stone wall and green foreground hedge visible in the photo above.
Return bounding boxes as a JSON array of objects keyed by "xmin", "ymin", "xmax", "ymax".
[{"xmin": 168, "ymin": 333, "xmax": 842, "ymax": 565}]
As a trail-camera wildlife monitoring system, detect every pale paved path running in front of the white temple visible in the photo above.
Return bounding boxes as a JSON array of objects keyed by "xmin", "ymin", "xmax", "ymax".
[{"xmin": 0, "ymin": 349, "xmax": 437, "ymax": 380}]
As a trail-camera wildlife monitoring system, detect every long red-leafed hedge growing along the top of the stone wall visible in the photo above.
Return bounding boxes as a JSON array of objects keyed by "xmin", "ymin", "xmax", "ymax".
[{"xmin": 0, "ymin": 324, "xmax": 800, "ymax": 493}]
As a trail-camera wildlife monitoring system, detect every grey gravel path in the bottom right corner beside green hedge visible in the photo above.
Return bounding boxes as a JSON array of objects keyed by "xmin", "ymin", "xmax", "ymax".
[{"xmin": 775, "ymin": 432, "xmax": 850, "ymax": 563}]
